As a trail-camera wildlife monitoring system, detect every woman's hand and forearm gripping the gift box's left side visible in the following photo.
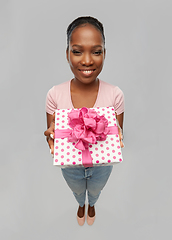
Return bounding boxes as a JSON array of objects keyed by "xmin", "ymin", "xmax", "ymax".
[{"xmin": 44, "ymin": 113, "xmax": 55, "ymax": 155}]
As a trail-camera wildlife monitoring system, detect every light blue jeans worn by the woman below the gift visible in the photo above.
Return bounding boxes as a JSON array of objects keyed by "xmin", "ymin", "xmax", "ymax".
[{"xmin": 61, "ymin": 165, "xmax": 113, "ymax": 207}]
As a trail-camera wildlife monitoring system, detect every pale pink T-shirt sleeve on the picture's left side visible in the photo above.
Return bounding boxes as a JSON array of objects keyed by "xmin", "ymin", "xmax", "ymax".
[{"xmin": 46, "ymin": 87, "xmax": 57, "ymax": 115}]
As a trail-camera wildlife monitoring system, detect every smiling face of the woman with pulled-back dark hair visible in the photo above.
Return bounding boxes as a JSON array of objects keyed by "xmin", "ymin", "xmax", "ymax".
[{"xmin": 66, "ymin": 24, "xmax": 105, "ymax": 84}]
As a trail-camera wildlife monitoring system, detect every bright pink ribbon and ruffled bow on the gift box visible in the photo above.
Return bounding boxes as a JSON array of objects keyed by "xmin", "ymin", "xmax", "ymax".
[{"xmin": 55, "ymin": 107, "xmax": 118, "ymax": 167}]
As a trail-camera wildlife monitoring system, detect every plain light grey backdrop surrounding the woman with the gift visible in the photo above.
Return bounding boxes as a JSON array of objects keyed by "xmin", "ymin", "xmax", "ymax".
[{"xmin": 0, "ymin": 0, "xmax": 172, "ymax": 240}]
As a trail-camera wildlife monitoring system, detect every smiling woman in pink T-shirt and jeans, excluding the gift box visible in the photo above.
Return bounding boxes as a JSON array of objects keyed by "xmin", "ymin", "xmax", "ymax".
[{"xmin": 45, "ymin": 17, "xmax": 124, "ymax": 226}]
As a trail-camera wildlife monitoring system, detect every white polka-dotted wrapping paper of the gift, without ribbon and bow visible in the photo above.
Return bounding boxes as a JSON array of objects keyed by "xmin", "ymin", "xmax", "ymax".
[{"xmin": 53, "ymin": 107, "xmax": 123, "ymax": 167}]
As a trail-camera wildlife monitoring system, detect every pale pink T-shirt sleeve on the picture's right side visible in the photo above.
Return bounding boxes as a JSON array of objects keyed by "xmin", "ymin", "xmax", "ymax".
[{"xmin": 114, "ymin": 87, "xmax": 124, "ymax": 115}]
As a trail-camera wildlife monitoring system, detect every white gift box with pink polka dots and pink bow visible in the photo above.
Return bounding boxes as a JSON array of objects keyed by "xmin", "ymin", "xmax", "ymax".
[{"xmin": 53, "ymin": 107, "xmax": 123, "ymax": 167}]
